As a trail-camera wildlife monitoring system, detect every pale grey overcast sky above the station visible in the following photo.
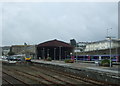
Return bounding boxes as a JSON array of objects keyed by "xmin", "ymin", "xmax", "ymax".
[{"xmin": 0, "ymin": 2, "xmax": 118, "ymax": 45}]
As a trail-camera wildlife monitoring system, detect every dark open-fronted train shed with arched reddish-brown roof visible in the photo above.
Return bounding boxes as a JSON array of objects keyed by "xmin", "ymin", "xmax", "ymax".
[{"xmin": 37, "ymin": 39, "xmax": 74, "ymax": 60}]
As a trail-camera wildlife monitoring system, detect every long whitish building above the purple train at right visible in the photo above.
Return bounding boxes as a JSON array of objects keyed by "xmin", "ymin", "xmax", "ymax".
[{"xmin": 77, "ymin": 39, "xmax": 120, "ymax": 55}]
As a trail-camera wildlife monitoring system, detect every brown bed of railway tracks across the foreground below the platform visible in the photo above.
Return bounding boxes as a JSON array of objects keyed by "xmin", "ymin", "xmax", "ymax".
[{"xmin": 3, "ymin": 64, "xmax": 118, "ymax": 86}]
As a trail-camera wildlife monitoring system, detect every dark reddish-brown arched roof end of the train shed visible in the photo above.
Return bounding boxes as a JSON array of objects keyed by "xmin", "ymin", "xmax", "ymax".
[{"xmin": 38, "ymin": 39, "xmax": 73, "ymax": 48}]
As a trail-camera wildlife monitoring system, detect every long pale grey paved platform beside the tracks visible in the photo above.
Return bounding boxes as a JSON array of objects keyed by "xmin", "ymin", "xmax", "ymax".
[{"xmin": 32, "ymin": 60, "xmax": 120, "ymax": 74}]
